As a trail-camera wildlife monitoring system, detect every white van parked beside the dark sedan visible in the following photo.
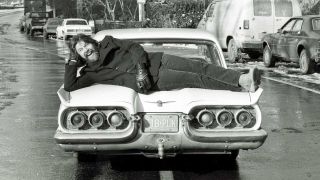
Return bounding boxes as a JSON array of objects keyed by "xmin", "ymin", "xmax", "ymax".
[{"xmin": 198, "ymin": 0, "xmax": 301, "ymax": 62}]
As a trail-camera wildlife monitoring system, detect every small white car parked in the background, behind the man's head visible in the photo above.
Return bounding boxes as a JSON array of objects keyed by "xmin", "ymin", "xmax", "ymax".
[{"xmin": 56, "ymin": 18, "xmax": 92, "ymax": 40}]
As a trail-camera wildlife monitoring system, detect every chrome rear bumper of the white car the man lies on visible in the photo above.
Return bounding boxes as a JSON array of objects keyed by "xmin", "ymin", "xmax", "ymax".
[{"xmin": 54, "ymin": 121, "xmax": 267, "ymax": 156}]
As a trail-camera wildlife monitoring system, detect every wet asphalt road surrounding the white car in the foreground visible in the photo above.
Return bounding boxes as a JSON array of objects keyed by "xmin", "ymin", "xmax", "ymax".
[{"xmin": 0, "ymin": 10, "xmax": 320, "ymax": 180}]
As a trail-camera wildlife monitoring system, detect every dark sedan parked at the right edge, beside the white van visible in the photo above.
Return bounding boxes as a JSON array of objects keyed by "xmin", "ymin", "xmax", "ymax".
[{"xmin": 262, "ymin": 15, "xmax": 320, "ymax": 74}]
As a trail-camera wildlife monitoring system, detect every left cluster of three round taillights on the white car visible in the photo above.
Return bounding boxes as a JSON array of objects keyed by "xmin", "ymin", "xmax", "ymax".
[{"xmin": 63, "ymin": 109, "xmax": 129, "ymax": 130}]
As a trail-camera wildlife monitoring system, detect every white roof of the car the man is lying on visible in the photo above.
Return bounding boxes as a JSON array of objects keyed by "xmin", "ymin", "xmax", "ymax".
[{"xmin": 94, "ymin": 28, "xmax": 218, "ymax": 44}]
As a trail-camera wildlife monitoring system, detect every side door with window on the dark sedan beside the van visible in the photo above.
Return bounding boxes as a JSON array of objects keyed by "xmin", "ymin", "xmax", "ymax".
[{"xmin": 272, "ymin": 19, "xmax": 296, "ymax": 59}]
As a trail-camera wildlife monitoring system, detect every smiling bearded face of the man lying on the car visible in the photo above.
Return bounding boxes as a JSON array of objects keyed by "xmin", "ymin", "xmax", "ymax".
[{"xmin": 76, "ymin": 41, "xmax": 99, "ymax": 63}]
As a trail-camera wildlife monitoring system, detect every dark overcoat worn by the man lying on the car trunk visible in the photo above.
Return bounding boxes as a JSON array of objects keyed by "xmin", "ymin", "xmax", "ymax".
[{"xmin": 64, "ymin": 36, "xmax": 163, "ymax": 91}]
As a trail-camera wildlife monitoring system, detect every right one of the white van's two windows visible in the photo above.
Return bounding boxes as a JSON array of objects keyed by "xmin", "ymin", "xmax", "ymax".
[{"xmin": 274, "ymin": 0, "xmax": 292, "ymax": 17}]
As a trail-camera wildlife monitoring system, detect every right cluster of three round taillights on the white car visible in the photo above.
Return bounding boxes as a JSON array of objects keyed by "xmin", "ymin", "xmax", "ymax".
[{"xmin": 191, "ymin": 108, "xmax": 256, "ymax": 129}]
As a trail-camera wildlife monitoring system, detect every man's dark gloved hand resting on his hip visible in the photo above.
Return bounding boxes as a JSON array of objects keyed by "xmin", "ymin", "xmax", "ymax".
[{"xmin": 136, "ymin": 63, "xmax": 151, "ymax": 93}]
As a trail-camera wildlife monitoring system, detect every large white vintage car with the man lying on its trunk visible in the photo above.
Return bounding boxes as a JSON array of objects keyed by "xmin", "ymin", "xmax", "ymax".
[{"xmin": 54, "ymin": 28, "xmax": 267, "ymax": 159}]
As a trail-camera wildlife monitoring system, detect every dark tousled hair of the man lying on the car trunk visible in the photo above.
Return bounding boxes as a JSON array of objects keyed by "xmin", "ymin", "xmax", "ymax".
[{"xmin": 69, "ymin": 34, "xmax": 99, "ymax": 64}]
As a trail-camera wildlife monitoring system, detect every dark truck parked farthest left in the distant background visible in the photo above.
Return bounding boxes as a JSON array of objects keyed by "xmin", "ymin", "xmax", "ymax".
[{"xmin": 25, "ymin": 12, "xmax": 49, "ymax": 36}]
